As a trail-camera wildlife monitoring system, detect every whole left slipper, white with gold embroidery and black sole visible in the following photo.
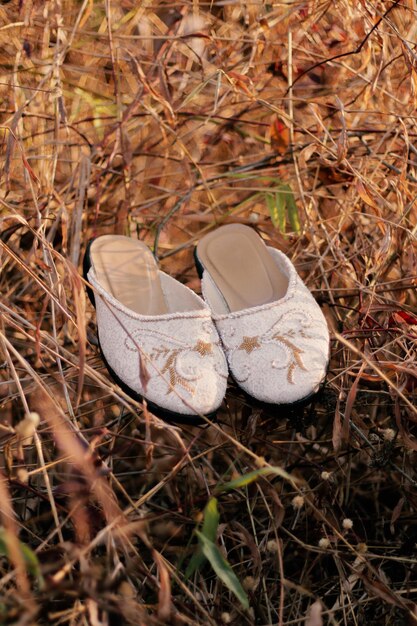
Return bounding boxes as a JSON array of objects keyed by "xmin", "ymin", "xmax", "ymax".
[{"xmin": 84, "ymin": 235, "xmax": 227, "ymax": 423}]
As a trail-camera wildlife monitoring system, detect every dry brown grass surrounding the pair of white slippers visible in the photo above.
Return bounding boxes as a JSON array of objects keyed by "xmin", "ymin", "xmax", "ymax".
[{"xmin": 0, "ymin": 0, "xmax": 417, "ymax": 626}]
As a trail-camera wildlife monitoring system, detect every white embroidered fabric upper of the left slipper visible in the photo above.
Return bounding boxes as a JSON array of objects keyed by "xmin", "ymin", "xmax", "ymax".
[{"xmin": 88, "ymin": 267, "xmax": 227, "ymax": 415}]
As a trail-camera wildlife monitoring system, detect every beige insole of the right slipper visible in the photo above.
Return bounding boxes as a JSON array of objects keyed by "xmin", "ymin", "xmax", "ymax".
[{"xmin": 197, "ymin": 224, "xmax": 288, "ymax": 311}]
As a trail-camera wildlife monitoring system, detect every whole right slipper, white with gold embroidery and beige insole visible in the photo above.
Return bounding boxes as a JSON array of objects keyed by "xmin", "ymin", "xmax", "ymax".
[{"xmin": 195, "ymin": 224, "xmax": 329, "ymax": 405}]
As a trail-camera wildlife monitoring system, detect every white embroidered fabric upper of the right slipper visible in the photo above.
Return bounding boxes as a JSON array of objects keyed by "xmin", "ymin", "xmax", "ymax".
[{"xmin": 202, "ymin": 247, "xmax": 329, "ymax": 404}]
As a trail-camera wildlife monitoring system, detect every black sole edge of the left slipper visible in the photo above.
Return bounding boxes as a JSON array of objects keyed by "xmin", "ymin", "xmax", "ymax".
[{"xmin": 83, "ymin": 238, "xmax": 217, "ymax": 426}]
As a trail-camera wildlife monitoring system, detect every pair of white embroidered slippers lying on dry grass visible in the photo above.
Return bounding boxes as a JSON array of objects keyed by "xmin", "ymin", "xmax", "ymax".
[{"xmin": 84, "ymin": 224, "xmax": 329, "ymax": 422}]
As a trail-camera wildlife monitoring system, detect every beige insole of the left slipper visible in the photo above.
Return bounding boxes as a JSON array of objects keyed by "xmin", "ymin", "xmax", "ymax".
[{"xmin": 90, "ymin": 235, "xmax": 168, "ymax": 315}]
